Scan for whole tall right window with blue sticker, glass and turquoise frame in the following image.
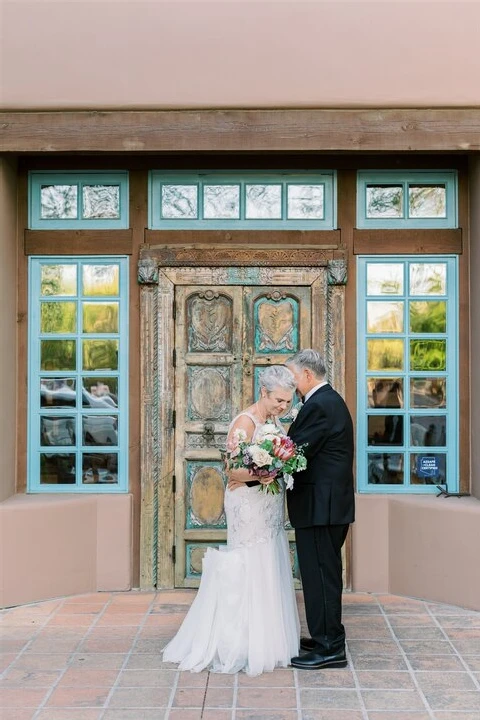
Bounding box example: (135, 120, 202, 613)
(357, 256, 458, 493)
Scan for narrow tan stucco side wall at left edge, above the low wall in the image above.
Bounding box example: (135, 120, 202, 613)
(0, 157, 17, 502)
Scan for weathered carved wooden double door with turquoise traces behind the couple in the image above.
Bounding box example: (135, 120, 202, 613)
(174, 285, 312, 587)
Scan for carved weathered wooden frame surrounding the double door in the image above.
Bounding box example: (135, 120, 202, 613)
(138, 246, 347, 589)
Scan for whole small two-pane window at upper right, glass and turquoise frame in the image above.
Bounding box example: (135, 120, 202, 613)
(357, 171, 458, 228)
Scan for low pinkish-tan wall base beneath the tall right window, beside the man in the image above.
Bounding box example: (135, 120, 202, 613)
(352, 495, 480, 610)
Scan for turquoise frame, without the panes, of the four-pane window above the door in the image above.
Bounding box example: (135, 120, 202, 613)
(148, 170, 337, 230)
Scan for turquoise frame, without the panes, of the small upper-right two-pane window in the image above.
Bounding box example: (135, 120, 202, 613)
(357, 170, 458, 229)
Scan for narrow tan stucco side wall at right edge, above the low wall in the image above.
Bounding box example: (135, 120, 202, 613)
(470, 156, 480, 500)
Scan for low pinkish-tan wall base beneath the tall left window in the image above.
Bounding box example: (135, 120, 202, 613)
(0, 495, 132, 607)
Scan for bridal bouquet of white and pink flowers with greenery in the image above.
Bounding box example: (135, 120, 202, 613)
(227, 423, 307, 494)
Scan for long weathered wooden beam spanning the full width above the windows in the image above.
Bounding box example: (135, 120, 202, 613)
(0, 108, 480, 154)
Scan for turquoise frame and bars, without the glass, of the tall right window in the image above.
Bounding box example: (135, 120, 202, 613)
(356, 255, 459, 494)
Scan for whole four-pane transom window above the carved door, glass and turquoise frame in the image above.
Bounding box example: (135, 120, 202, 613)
(149, 171, 336, 229)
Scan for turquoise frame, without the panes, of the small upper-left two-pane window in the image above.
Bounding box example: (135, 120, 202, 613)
(28, 170, 129, 230)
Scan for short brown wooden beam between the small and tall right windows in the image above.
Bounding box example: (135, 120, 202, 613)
(353, 229, 463, 255)
